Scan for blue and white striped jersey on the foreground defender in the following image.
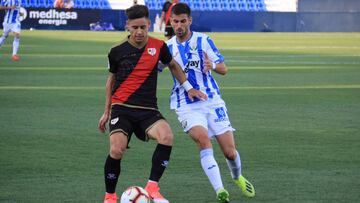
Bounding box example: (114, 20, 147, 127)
(166, 32, 224, 109)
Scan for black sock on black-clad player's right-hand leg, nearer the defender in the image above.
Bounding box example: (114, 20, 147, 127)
(149, 144, 172, 182)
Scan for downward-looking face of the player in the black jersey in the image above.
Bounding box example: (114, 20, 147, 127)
(126, 18, 150, 44)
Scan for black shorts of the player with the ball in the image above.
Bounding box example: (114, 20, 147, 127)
(109, 105, 165, 141)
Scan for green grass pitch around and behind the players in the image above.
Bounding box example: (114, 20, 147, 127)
(0, 30, 360, 203)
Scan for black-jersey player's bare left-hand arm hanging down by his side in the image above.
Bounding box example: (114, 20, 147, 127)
(98, 73, 115, 133)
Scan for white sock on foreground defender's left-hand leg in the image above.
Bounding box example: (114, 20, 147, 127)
(200, 148, 224, 192)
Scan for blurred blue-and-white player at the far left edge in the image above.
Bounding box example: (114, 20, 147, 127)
(0, 0, 21, 61)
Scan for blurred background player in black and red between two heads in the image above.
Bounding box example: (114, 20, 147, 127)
(160, 0, 179, 39)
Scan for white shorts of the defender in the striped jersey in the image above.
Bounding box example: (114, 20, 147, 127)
(175, 99, 235, 138)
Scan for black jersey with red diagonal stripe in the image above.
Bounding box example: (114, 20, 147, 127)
(108, 37, 172, 109)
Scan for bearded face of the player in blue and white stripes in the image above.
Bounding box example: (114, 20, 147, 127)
(171, 14, 192, 40)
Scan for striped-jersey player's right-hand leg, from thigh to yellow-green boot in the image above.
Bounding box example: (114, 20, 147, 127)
(216, 130, 255, 197)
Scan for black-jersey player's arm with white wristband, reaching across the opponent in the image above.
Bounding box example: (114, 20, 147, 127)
(168, 59, 207, 101)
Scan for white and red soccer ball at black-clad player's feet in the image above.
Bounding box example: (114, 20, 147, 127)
(120, 186, 150, 203)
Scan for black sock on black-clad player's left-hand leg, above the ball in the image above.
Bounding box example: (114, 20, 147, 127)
(104, 155, 121, 193)
